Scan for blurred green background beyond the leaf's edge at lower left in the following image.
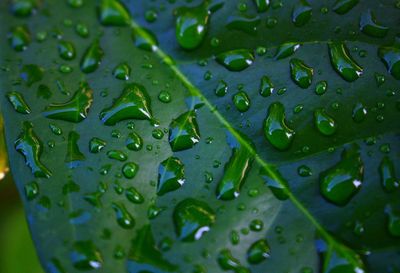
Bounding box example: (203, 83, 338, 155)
(0, 117, 44, 273)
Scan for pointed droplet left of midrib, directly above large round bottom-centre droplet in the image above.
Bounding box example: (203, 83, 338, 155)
(157, 157, 185, 196)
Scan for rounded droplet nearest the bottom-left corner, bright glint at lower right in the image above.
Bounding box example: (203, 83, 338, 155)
(71, 241, 103, 271)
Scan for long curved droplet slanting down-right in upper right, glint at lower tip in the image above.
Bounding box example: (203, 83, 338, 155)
(329, 42, 363, 82)
